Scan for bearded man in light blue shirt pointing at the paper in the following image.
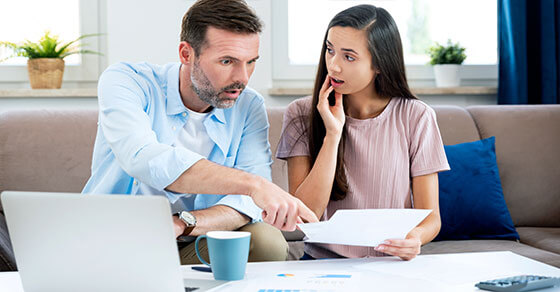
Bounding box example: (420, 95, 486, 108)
(83, 0, 317, 264)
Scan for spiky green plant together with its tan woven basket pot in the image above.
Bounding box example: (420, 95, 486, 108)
(0, 31, 101, 89)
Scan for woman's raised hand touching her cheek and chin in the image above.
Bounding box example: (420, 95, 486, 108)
(317, 76, 346, 138)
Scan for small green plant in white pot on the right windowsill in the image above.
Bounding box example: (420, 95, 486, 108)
(428, 40, 467, 87)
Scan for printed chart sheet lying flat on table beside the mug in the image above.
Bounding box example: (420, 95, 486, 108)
(249, 271, 359, 292)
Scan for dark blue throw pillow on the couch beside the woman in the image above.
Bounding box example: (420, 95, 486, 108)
(434, 137, 519, 240)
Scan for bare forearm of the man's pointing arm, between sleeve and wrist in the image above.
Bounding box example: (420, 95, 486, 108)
(166, 159, 263, 195)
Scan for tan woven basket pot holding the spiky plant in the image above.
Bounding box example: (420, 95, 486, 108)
(27, 58, 64, 89)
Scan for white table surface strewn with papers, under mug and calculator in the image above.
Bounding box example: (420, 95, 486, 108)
(0, 251, 560, 292)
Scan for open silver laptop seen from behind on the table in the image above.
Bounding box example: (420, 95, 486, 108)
(1, 191, 225, 292)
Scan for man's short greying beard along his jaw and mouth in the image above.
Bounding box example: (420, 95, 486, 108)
(191, 60, 245, 108)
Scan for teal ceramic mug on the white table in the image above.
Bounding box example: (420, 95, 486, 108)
(194, 231, 251, 281)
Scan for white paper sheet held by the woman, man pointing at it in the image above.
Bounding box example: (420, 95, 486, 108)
(298, 209, 432, 246)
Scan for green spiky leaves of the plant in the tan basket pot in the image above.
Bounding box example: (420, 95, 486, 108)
(0, 31, 102, 62)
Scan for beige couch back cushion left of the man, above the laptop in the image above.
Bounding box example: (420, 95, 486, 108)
(0, 110, 97, 202)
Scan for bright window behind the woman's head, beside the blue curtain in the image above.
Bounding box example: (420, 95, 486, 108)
(272, 0, 497, 85)
